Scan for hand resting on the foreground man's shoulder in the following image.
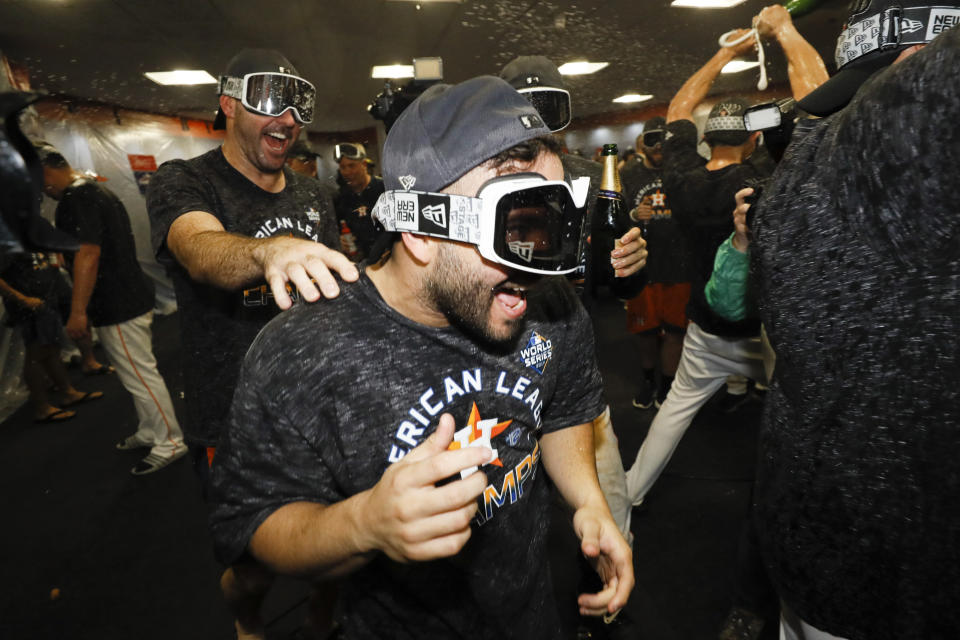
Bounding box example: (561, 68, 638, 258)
(254, 236, 360, 309)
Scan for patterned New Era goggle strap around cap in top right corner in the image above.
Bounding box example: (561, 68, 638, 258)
(834, 5, 960, 69)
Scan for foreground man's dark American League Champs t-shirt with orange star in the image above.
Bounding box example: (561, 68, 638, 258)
(211, 275, 605, 640)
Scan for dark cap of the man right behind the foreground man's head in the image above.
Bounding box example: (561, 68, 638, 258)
(500, 56, 571, 131)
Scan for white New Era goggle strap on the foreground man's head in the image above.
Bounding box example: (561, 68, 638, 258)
(373, 191, 483, 244)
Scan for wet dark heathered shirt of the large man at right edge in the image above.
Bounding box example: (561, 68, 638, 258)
(751, 28, 960, 640)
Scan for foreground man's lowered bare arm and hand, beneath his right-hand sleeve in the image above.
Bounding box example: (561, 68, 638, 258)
(540, 423, 634, 616)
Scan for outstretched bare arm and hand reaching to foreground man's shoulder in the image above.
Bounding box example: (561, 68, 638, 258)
(166, 211, 359, 309)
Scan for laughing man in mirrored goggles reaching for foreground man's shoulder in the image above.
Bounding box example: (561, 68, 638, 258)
(147, 49, 358, 638)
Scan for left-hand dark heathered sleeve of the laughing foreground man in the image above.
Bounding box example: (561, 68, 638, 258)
(210, 318, 342, 564)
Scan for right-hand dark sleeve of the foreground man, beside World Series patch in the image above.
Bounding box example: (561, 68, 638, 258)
(543, 300, 606, 433)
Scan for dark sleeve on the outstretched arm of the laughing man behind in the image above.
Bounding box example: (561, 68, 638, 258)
(147, 160, 216, 264)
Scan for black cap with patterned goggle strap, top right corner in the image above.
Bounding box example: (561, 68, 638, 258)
(797, 0, 960, 116)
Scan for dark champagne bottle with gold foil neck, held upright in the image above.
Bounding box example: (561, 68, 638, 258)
(591, 144, 643, 299)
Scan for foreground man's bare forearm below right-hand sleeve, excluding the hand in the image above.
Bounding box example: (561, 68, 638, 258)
(540, 423, 612, 518)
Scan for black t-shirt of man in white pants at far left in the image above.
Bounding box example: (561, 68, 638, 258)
(56, 178, 154, 327)
